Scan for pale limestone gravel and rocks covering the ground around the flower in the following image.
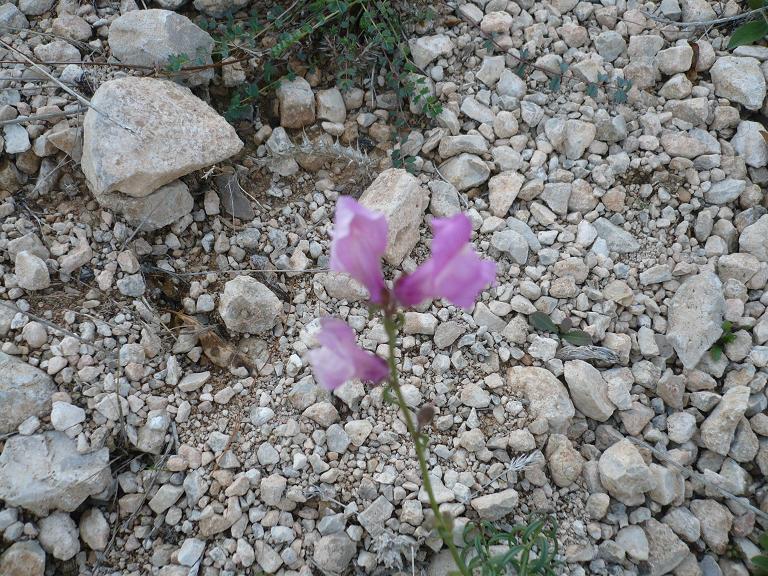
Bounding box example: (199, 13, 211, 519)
(0, 0, 768, 576)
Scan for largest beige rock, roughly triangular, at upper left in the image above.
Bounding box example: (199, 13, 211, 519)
(82, 76, 243, 198)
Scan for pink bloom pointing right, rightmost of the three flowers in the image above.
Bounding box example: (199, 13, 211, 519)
(395, 214, 496, 308)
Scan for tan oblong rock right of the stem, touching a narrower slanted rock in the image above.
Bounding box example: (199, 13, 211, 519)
(507, 366, 576, 432)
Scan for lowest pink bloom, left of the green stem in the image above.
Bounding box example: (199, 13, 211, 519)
(309, 316, 389, 390)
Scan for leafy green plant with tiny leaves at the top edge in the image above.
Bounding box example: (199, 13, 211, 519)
(200, 0, 442, 130)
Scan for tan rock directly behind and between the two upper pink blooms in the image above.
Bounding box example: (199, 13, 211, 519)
(360, 168, 429, 266)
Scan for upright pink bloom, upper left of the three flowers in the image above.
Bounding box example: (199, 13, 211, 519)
(331, 196, 387, 303)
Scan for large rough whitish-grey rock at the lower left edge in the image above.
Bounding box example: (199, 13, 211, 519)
(0, 432, 112, 516)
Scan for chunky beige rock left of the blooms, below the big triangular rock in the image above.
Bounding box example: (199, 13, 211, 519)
(219, 276, 283, 334)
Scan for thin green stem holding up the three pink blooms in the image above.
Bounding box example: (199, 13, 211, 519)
(384, 313, 472, 576)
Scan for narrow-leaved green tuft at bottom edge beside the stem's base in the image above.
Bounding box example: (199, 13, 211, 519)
(462, 516, 557, 576)
